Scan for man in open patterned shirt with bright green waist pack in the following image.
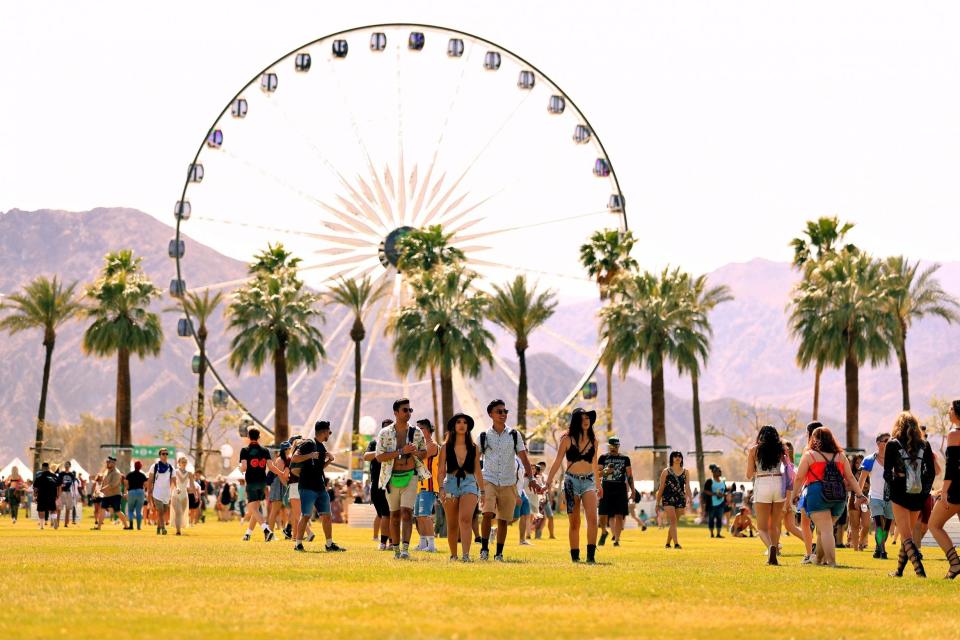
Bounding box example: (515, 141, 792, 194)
(376, 398, 430, 560)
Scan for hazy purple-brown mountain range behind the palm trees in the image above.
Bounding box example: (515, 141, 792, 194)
(0, 208, 960, 468)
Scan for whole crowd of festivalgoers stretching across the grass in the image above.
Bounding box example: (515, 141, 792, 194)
(2, 398, 960, 578)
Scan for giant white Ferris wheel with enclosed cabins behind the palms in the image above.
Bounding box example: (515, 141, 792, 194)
(168, 24, 627, 442)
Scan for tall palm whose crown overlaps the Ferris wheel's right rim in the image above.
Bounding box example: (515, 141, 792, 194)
(580, 229, 639, 431)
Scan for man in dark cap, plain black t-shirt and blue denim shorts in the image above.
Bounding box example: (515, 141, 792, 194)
(290, 420, 346, 551)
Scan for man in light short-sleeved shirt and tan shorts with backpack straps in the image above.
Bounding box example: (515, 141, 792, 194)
(480, 400, 533, 562)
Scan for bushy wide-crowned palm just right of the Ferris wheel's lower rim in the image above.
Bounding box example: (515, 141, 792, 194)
(600, 269, 708, 466)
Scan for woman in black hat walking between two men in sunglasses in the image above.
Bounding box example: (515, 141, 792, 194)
(437, 413, 483, 562)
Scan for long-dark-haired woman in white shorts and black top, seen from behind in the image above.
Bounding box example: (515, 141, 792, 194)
(747, 425, 786, 565)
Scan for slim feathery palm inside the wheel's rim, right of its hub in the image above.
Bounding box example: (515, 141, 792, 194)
(490, 275, 557, 434)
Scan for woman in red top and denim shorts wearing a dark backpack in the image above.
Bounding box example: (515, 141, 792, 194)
(793, 427, 864, 567)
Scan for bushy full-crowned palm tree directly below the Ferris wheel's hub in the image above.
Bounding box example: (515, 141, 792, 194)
(387, 265, 494, 424)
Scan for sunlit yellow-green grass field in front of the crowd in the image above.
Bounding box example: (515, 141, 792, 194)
(0, 518, 960, 640)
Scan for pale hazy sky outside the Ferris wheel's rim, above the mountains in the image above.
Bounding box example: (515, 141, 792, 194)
(0, 0, 960, 271)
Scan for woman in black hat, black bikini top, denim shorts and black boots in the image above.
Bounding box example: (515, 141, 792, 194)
(547, 407, 603, 564)
